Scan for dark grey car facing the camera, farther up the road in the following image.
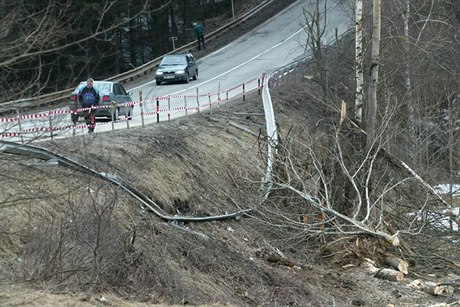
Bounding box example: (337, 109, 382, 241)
(155, 53, 198, 85)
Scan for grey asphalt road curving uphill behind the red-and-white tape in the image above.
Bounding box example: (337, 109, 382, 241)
(1, 0, 351, 142)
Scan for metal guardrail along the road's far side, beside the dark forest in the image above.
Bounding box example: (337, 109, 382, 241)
(0, 0, 274, 113)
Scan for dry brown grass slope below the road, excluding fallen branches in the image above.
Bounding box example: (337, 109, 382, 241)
(0, 0, 460, 306)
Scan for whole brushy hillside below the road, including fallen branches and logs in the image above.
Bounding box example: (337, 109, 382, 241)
(0, 1, 460, 306)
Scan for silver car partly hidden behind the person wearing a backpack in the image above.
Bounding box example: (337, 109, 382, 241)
(69, 81, 134, 124)
